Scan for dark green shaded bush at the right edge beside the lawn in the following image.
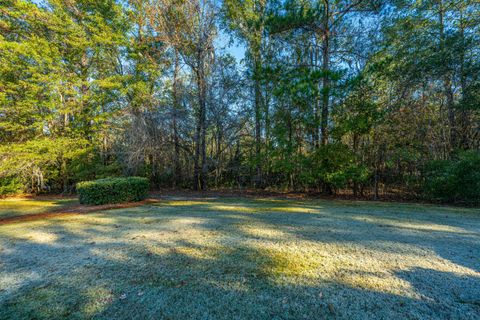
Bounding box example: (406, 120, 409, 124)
(425, 151, 480, 204)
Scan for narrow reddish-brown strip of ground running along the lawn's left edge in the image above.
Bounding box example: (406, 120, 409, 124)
(0, 199, 160, 225)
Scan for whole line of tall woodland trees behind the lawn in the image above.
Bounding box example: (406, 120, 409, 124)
(0, 0, 480, 203)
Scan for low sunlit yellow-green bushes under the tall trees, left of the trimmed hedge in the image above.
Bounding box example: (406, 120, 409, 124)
(0, 138, 123, 196)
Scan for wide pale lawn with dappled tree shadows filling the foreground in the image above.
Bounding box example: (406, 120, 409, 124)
(0, 198, 480, 319)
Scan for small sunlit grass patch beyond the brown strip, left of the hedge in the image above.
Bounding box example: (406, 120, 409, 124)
(0, 197, 78, 219)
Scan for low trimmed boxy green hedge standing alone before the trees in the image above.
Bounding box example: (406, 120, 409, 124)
(77, 177, 150, 205)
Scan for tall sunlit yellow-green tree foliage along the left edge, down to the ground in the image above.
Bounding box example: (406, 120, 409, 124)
(0, 0, 128, 193)
